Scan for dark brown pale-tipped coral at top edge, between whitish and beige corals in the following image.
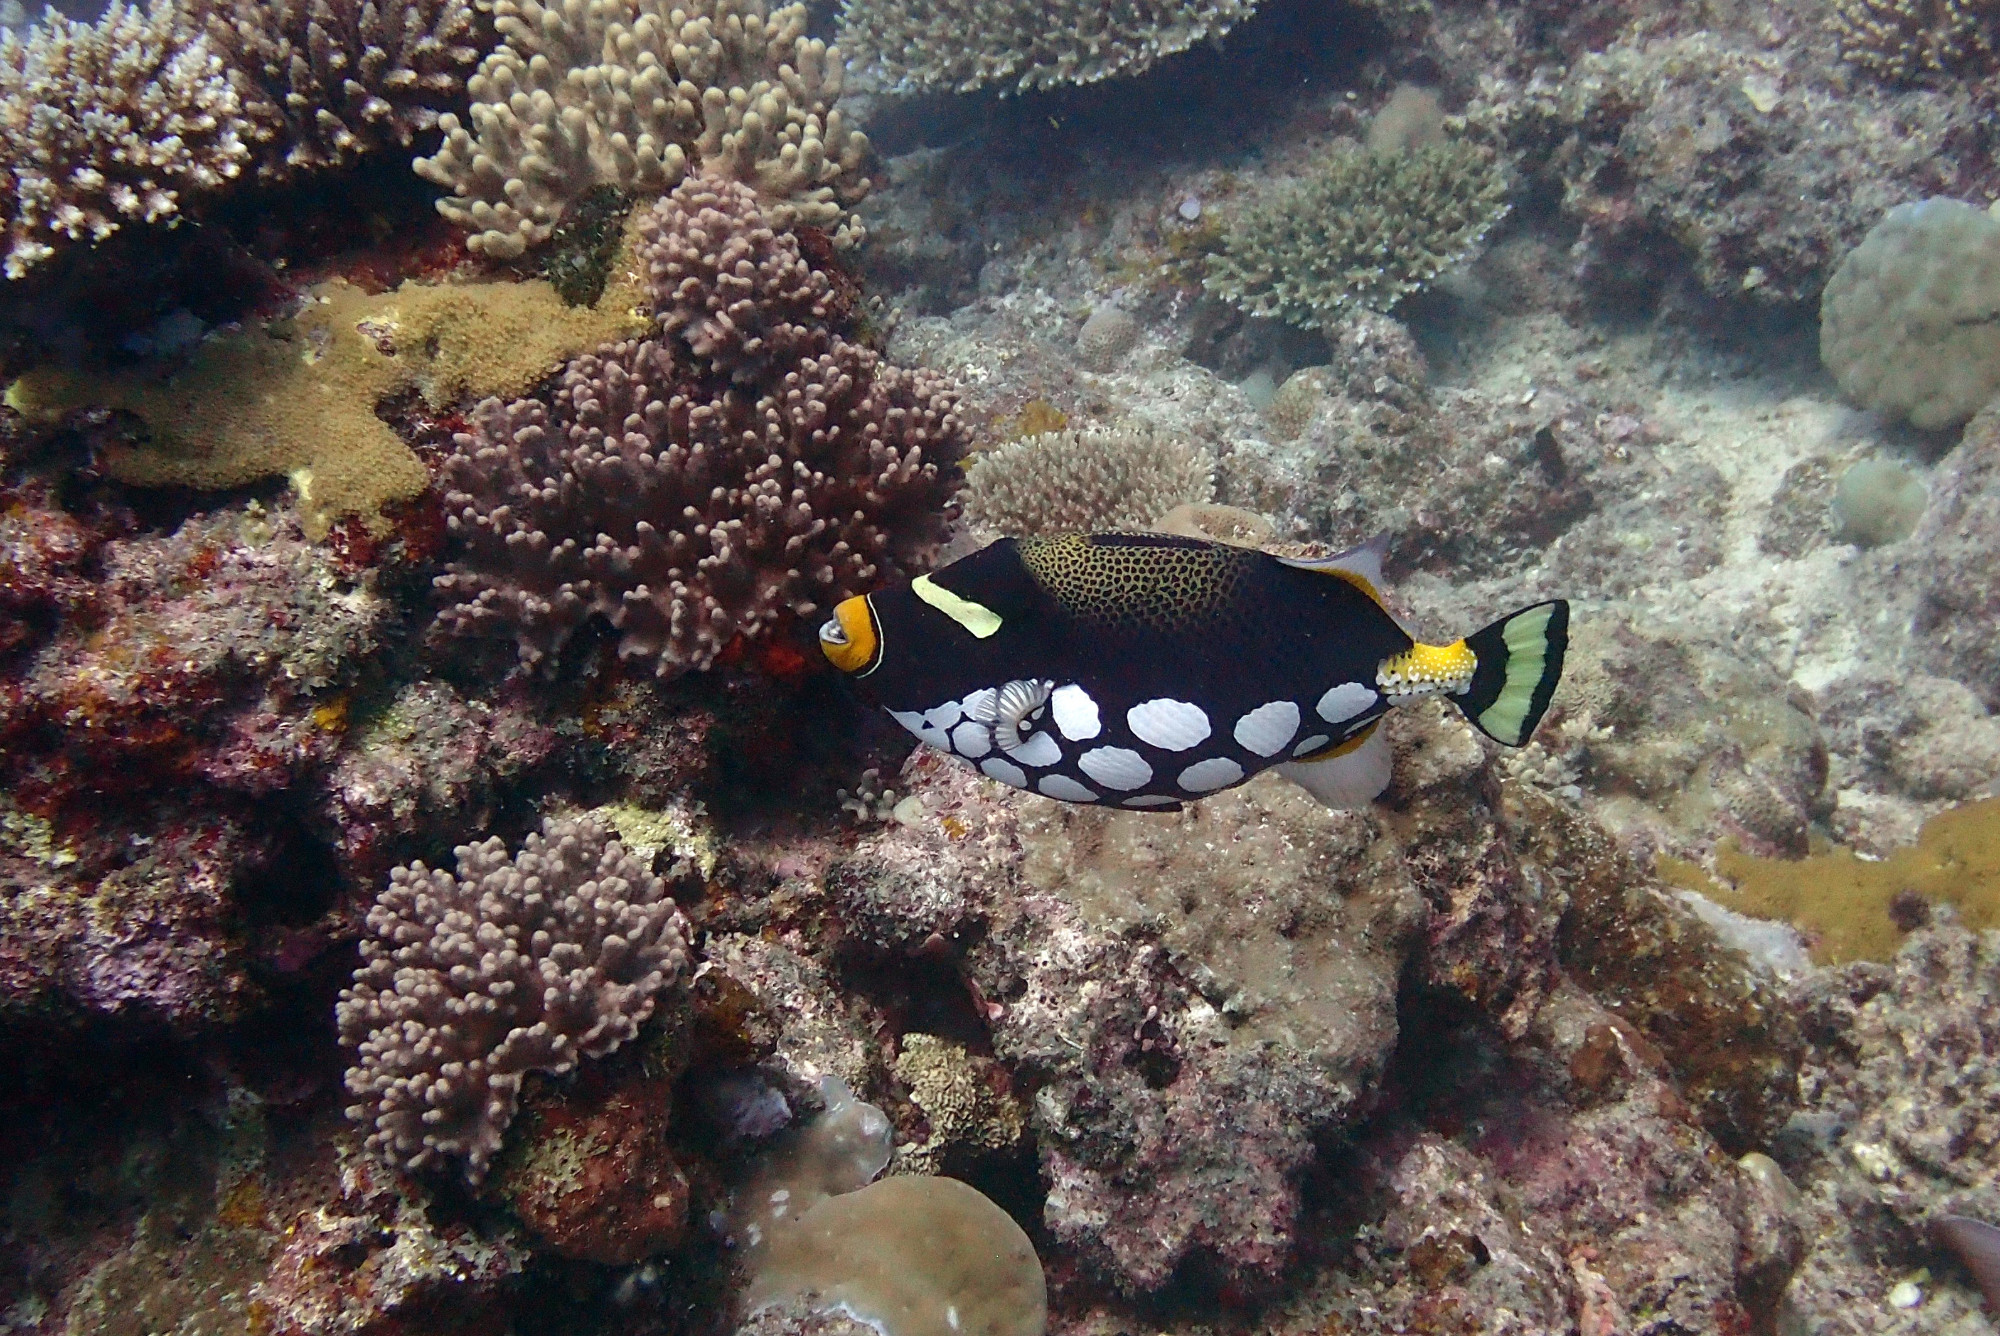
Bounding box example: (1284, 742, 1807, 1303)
(188, 0, 490, 176)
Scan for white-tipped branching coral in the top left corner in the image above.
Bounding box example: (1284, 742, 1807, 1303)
(0, 0, 254, 278)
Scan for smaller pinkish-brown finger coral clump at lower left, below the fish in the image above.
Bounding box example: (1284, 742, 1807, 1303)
(336, 818, 688, 1184)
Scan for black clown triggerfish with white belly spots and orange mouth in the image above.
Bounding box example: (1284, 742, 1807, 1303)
(820, 534, 1570, 810)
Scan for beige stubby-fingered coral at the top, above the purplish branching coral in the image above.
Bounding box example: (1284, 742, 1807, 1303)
(414, 0, 868, 260)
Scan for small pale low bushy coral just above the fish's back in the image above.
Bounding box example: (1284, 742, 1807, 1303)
(966, 426, 1216, 536)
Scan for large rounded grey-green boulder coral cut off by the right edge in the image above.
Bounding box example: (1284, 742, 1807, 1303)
(1820, 200, 2000, 430)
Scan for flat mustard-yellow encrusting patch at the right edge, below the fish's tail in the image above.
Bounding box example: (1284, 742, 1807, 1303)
(1660, 798, 2000, 964)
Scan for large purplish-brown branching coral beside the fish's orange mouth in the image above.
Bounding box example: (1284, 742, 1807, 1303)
(438, 180, 966, 676)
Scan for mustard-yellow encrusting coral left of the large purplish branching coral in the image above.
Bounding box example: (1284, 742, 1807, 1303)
(10, 235, 644, 538)
